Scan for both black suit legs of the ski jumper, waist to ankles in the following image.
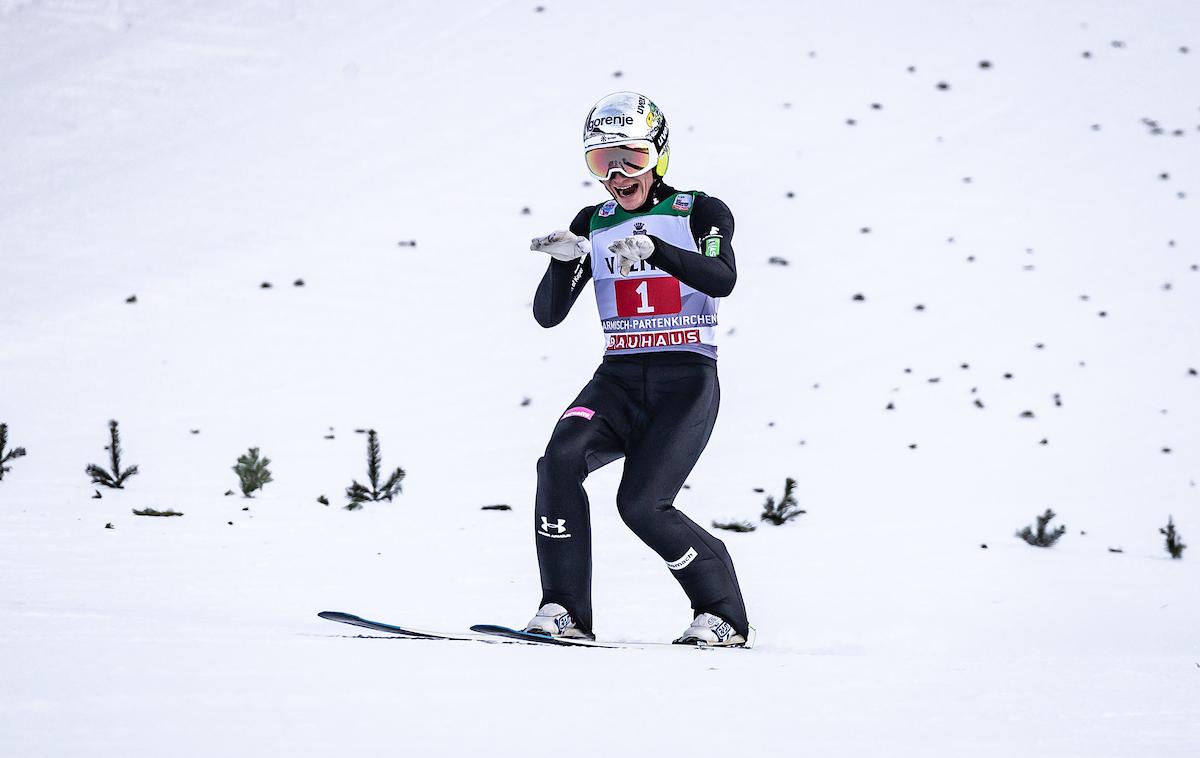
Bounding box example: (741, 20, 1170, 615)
(534, 362, 749, 636)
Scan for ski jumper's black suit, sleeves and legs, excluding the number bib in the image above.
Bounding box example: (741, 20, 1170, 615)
(533, 184, 749, 637)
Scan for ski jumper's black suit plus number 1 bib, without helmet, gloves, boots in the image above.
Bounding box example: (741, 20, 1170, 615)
(534, 184, 749, 636)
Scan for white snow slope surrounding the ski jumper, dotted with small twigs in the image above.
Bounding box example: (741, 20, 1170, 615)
(0, 0, 1200, 757)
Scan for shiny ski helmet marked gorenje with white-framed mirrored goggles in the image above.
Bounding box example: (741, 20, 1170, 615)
(583, 92, 671, 179)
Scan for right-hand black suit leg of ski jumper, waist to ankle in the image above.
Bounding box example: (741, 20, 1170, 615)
(617, 366, 749, 636)
